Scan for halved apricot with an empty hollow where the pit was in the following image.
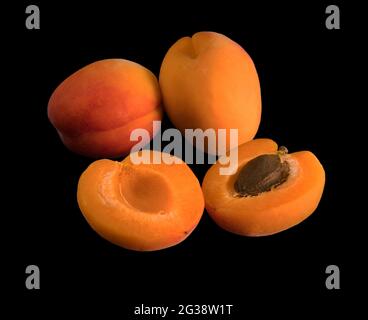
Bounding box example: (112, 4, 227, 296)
(77, 150, 204, 251)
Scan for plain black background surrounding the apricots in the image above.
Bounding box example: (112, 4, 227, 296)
(3, 1, 359, 319)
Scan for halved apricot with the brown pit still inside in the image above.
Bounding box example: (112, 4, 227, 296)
(202, 139, 325, 236)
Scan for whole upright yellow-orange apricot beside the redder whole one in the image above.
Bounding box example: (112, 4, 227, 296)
(159, 32, 261, 154)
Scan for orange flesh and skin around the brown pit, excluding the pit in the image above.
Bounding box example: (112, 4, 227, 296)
(202, 139, 325, 236)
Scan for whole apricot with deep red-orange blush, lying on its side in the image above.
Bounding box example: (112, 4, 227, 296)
(48, 59, 162, 158)
